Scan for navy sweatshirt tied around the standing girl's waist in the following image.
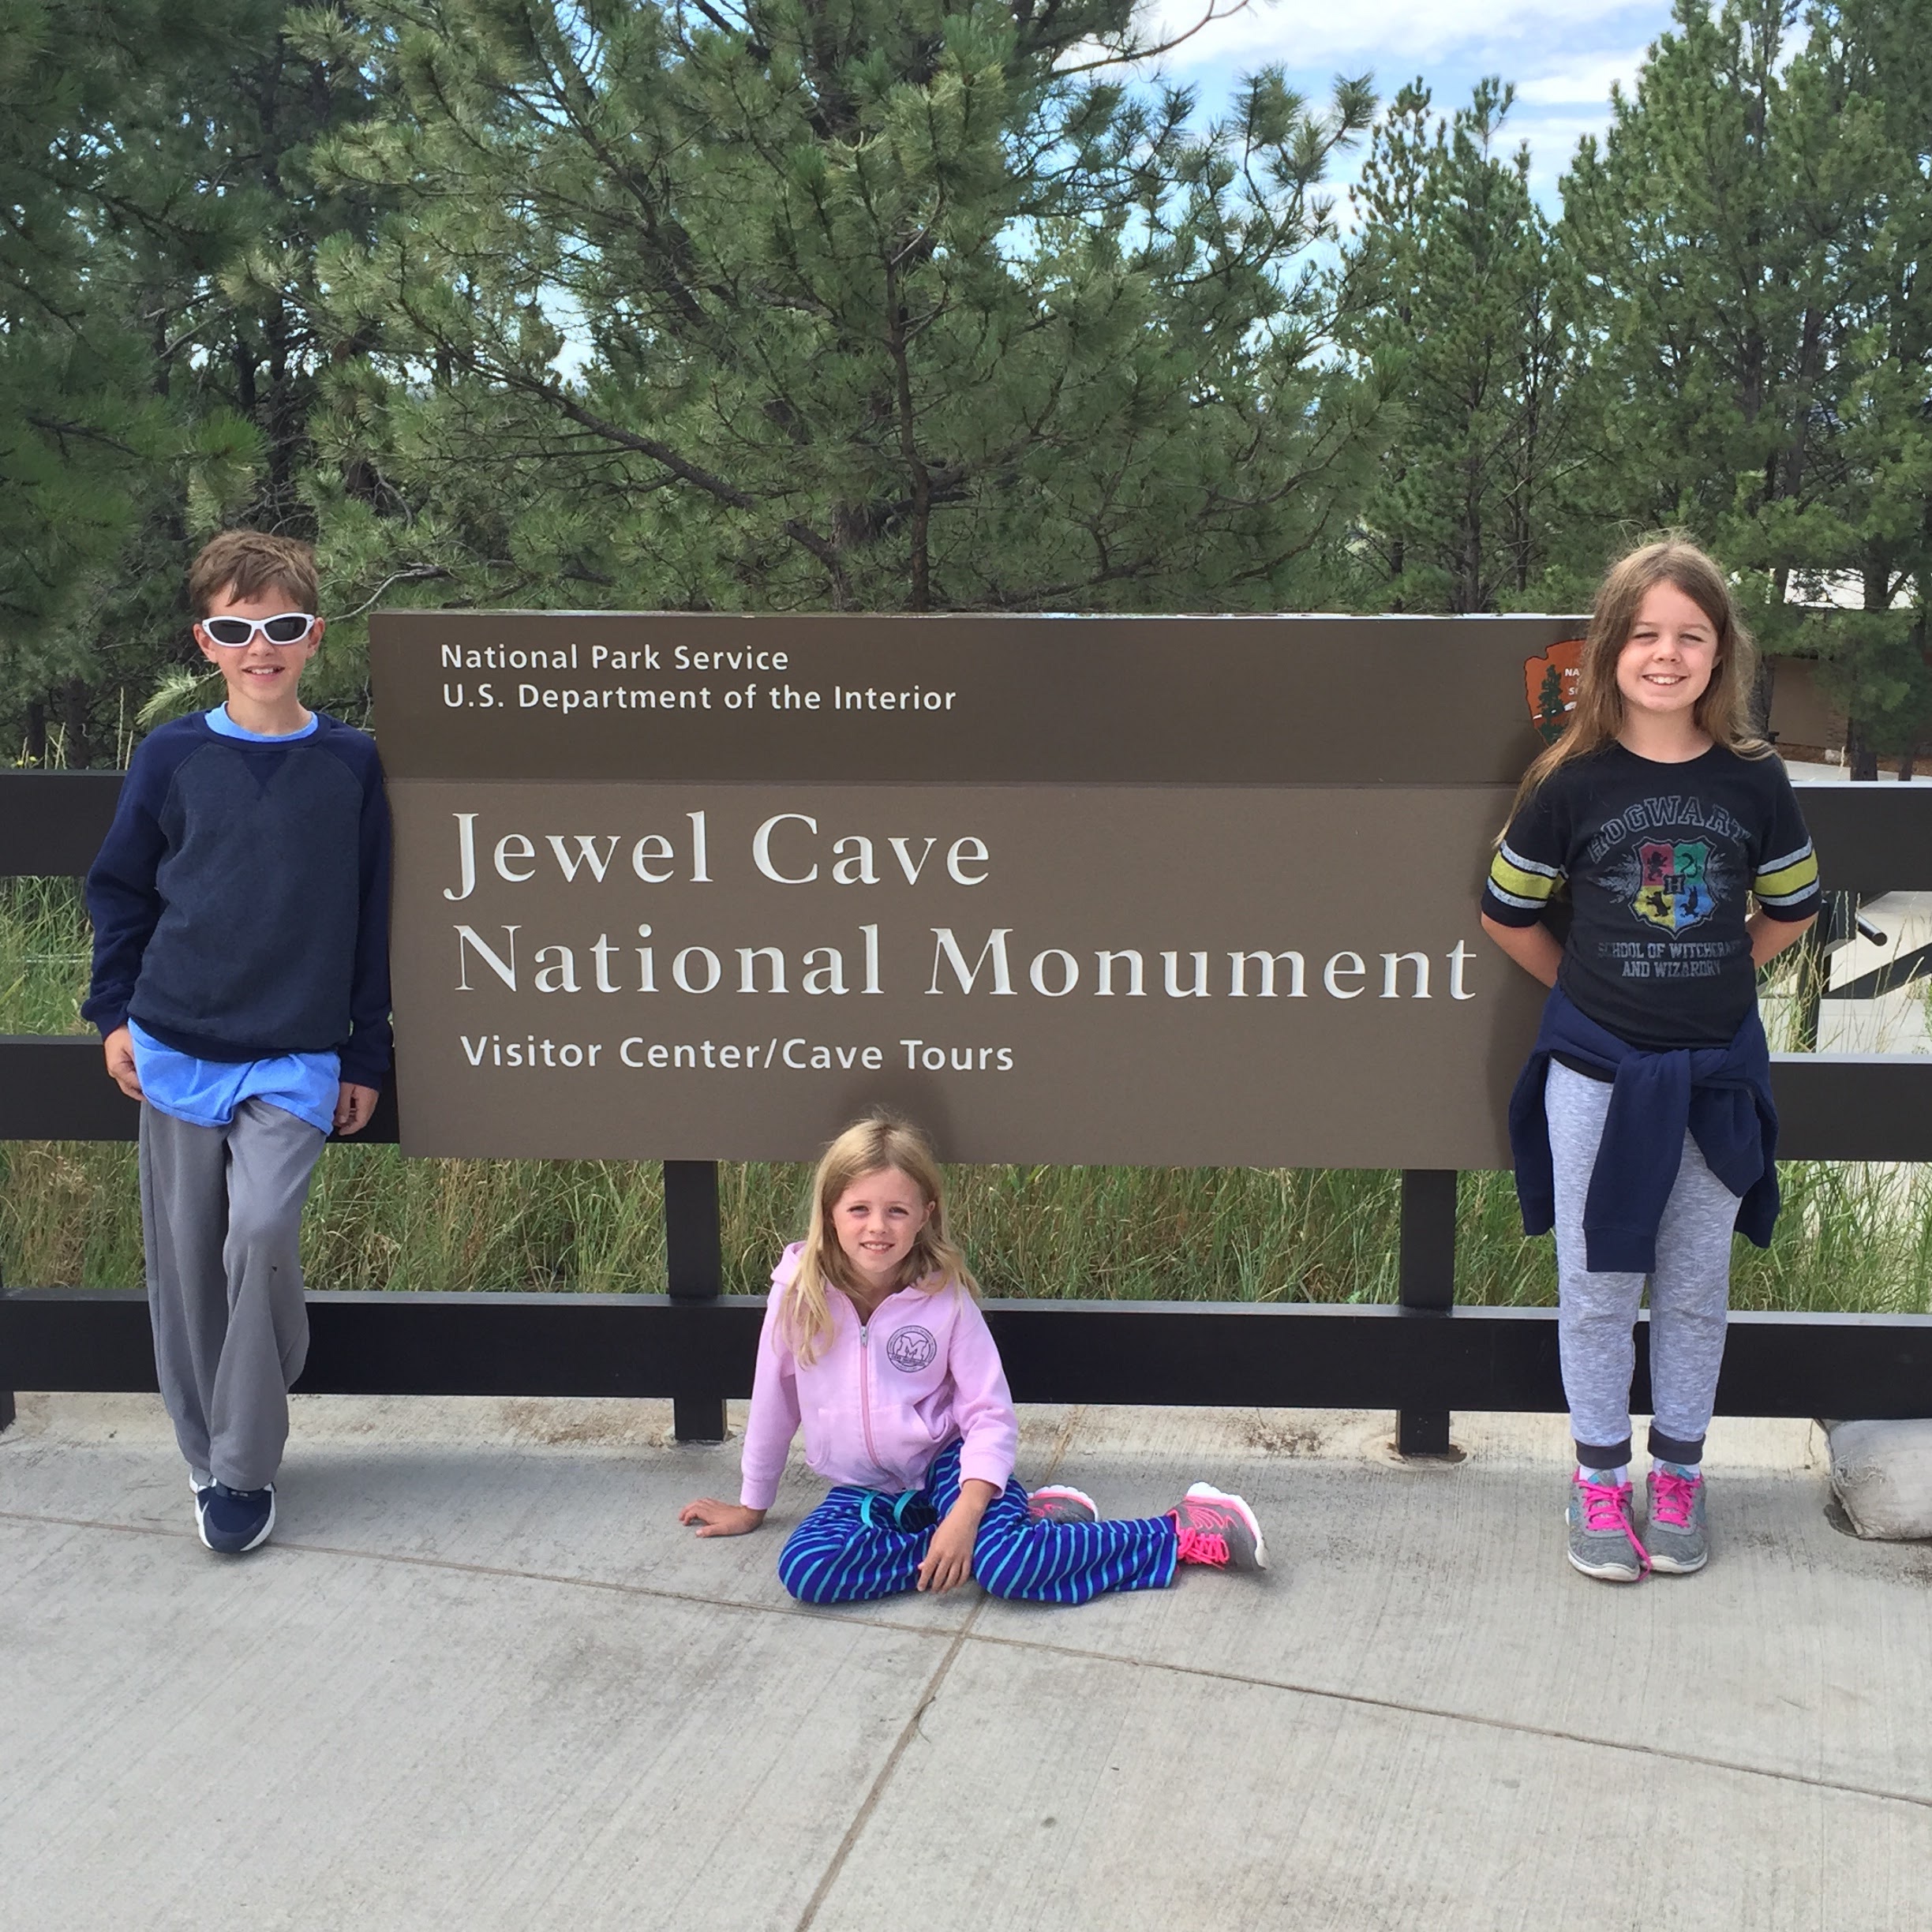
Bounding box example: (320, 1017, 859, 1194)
(1509, 987, 1777, 1275)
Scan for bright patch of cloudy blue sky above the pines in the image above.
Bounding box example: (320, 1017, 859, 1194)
(1146, 0, 1672, 212)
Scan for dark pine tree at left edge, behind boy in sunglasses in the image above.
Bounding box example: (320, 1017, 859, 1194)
(0, 0, 391, 763)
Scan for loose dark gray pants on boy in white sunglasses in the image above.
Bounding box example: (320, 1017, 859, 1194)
(141, 1099, 323, 1489)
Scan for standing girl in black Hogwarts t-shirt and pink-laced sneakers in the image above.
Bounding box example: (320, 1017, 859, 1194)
(1482, 541, 1818, 1582)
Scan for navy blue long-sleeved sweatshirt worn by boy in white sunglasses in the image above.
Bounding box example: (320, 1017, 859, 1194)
(81, 713, 390, 1086)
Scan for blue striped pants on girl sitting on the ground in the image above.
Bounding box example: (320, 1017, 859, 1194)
(779, 1443, 1174, 1604)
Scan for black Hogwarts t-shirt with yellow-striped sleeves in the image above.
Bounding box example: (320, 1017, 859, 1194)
(1482, 743, 1818, 1053)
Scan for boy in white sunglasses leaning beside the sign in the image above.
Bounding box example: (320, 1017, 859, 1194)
(81, 530, 390, 1556)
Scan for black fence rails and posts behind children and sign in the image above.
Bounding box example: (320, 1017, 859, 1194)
(0, 773, 1932, 1455)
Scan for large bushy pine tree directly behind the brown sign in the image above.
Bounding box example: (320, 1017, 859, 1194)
(297, 0, 1385, 649)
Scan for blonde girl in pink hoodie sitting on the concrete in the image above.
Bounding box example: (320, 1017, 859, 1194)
(678, 1114, 1267, 1604)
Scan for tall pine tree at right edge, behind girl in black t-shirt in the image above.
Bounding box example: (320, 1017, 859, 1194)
(1563, 0, 1932, 777)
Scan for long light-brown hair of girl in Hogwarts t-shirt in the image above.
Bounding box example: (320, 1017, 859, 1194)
(1509, 535, 1772, 818)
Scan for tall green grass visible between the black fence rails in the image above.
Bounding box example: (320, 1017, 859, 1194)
(0, 879, 1932, 1312)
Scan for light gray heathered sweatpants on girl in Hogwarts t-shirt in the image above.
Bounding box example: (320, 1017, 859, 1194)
(1544, 1061, 1737, 1468)
